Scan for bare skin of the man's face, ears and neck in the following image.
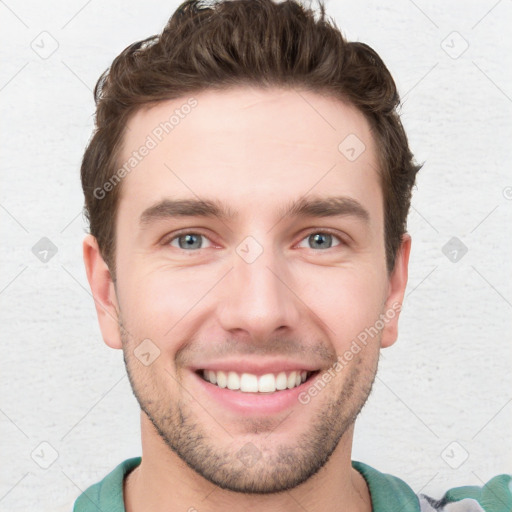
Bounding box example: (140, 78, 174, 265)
(83, 87, 410, 512)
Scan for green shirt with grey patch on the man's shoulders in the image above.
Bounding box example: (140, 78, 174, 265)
(73, 457, 512, 512)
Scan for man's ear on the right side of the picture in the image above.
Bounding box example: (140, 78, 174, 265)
(380, 233, 411, 348)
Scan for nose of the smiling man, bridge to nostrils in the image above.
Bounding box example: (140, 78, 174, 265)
(218, 240, 304, 343)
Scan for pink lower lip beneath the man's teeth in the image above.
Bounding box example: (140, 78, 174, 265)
(192, 372, 320, 416)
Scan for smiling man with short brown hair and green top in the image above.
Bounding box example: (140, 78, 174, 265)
(74, 0, 512, 512)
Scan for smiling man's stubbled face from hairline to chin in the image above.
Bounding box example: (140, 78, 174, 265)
(86, 88, 408, 493)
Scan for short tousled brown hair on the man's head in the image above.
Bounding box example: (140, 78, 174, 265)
(81, 0, 421, 281)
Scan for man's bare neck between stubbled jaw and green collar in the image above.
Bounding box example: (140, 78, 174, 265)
(123, 414, 372, 512)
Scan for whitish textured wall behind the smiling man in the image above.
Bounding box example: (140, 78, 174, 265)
(0, 0, 512, 511)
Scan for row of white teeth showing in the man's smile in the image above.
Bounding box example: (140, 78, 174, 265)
(203, 370, 310, 393)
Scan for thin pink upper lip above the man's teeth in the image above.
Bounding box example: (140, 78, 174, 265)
(192, 358, 320, 376)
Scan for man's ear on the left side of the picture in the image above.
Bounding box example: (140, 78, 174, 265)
(83, 235, 122, 349)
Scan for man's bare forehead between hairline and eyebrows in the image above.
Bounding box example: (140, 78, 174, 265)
(118, 87, 382, 227)
